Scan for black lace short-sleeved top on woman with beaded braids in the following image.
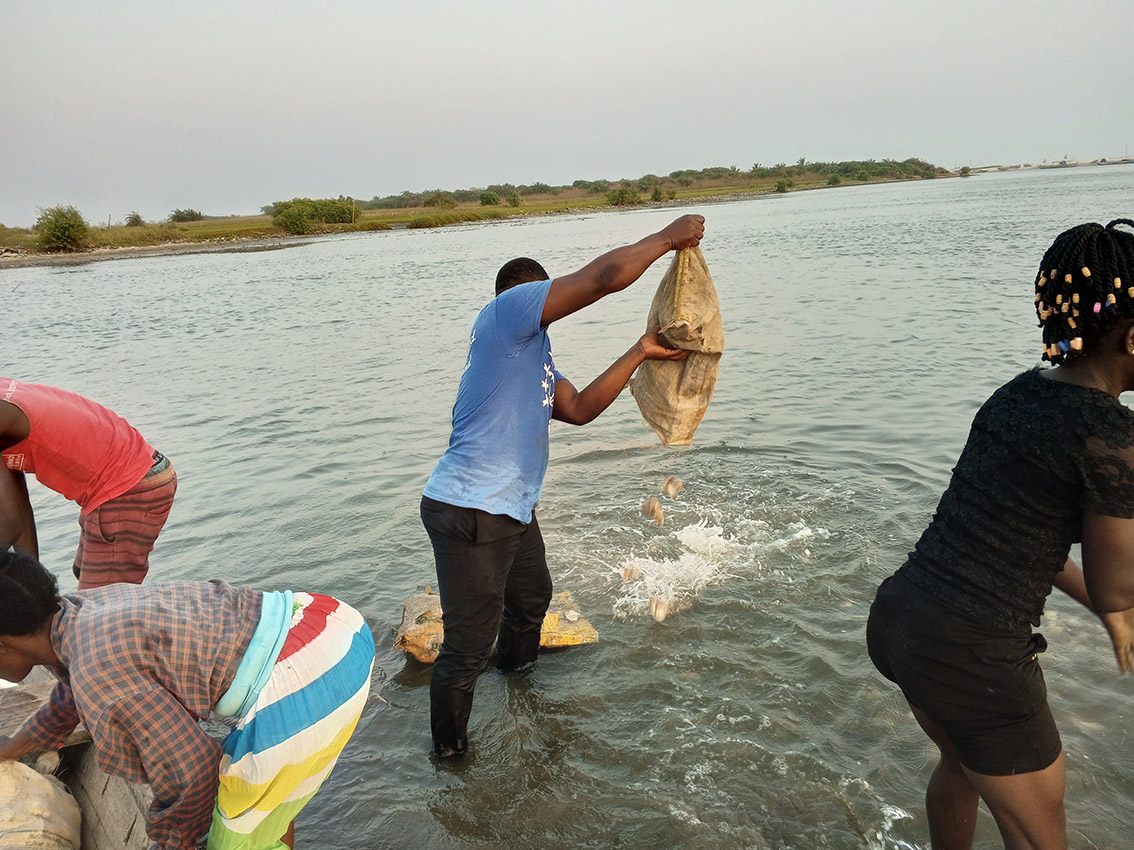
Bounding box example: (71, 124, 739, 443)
(899, 369, 1134, 634)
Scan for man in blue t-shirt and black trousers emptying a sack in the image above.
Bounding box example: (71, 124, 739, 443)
(421, 215, 704, 758)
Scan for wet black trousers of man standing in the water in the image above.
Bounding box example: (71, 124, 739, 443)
(421, 496, 551, 753)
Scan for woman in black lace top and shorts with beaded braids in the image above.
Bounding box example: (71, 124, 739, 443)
(866, 219, 1134, 850)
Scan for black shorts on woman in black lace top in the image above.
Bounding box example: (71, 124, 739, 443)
(866, 575, 1063, 776)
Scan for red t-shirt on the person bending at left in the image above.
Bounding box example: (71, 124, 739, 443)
(0, 377, 153, 513)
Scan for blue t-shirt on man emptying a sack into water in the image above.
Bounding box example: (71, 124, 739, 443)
(425, 280, 562, 522)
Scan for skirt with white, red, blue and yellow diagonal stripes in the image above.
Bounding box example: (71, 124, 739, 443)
(209, 593, 374, 850)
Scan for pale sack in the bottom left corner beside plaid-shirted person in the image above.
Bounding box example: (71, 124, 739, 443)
(0, 762, 82, 850)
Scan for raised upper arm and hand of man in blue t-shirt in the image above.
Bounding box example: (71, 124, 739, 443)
(540, 215, 705, 328)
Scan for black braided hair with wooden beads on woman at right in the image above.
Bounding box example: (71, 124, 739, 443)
(1035, 219, 1134, 364)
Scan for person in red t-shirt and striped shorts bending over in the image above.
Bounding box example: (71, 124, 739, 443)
(0, 377, 177, 589)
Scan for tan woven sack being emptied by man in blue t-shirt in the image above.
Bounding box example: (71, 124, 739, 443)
(631, 248, 725, 445)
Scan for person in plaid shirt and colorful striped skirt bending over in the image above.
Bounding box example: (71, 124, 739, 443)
(0, 552, 374, 850)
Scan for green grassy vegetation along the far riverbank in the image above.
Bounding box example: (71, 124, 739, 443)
(0, 159, 950, 253)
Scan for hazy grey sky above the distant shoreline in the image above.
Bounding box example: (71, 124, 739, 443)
(0, 0, 1134, 227)
